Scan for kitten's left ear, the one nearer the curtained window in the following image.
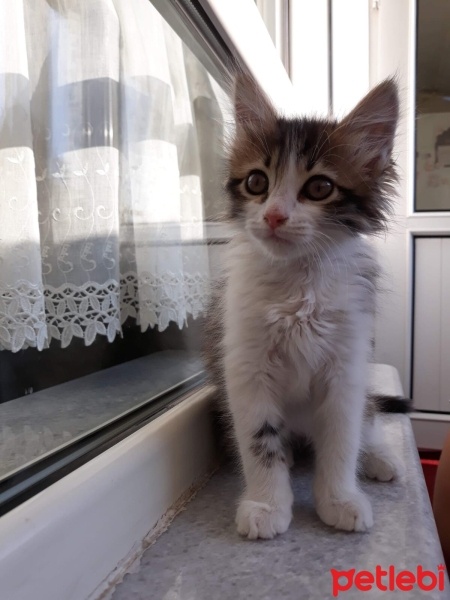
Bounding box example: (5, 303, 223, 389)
(233, 72, 277, 131)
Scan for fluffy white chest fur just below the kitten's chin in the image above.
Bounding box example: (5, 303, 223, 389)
(225, 234, 375, 380)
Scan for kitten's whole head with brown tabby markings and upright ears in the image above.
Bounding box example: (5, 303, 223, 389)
(227, 75, 398, 259)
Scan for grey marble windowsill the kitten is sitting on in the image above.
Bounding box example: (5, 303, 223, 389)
(111, 365, 450, 600)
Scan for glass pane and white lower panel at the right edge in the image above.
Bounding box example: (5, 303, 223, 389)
(411, 0, 450, 412)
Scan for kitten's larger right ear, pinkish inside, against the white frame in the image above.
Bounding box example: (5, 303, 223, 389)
(338, 79, 399, 173)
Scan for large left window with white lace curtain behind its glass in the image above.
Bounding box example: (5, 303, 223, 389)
(0, 0, 229, 510)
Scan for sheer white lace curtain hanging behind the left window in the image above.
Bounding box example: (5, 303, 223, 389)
(0, 0, 223, 352)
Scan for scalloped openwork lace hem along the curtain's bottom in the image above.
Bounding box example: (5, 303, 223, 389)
(0, 272, 209, 352)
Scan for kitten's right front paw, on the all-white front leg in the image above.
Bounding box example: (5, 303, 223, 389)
(316, 491, 373, 531)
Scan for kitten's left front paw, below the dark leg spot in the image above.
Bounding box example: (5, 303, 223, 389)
(236, 500, 292, 540)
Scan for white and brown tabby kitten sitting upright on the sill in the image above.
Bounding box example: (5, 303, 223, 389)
(207, 74, 408, 539)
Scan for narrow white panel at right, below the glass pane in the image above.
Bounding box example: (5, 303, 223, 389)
(413, 238, 442, 411)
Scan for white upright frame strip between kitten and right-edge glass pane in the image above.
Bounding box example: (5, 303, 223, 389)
(370, 0, 415, 394)
